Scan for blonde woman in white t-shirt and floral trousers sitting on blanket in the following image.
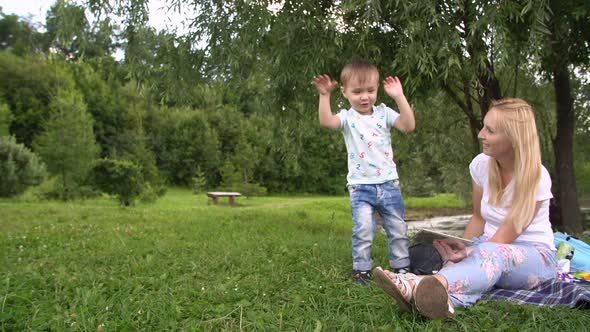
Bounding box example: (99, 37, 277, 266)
(373, 98, 557, 318)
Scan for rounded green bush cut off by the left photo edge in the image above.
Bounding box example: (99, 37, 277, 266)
(0, 136, 47, 197)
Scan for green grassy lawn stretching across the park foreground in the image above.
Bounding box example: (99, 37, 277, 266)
(0, 189, 590, 331)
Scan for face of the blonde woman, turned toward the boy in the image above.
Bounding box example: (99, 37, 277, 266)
(477, 108, 514, 159)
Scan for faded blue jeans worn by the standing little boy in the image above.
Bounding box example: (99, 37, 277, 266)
(348, 180, 410, 271)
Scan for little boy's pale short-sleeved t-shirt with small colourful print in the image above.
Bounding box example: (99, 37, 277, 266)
(336, 104, 399, 184)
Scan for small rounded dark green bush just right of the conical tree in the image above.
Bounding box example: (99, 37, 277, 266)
(90, 159, 144, 206)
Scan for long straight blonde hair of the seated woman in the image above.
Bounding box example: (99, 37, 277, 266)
(489, 98, 541, 234)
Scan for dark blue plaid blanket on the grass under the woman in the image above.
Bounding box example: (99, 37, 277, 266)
(483, 278, 590, 309)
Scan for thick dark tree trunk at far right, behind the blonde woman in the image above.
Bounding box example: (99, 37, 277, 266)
(551, 66, 583, 234)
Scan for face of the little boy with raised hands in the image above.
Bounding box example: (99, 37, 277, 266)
(341, 74, 379, 115)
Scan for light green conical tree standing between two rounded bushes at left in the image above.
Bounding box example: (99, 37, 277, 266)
(34, 90, 99, 199)
